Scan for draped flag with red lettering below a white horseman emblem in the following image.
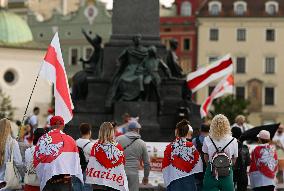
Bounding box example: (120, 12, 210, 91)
(86, 141, 128, 191)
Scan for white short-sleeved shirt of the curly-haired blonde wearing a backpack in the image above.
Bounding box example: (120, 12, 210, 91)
(202, 136, 238, 161)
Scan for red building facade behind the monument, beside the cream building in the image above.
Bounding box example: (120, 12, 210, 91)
(160, 0, 201, 73)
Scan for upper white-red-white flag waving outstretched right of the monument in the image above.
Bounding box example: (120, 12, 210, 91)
(186, 54, 233, 93)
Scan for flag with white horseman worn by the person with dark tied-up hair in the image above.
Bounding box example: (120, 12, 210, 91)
(162, 138, 203, 186)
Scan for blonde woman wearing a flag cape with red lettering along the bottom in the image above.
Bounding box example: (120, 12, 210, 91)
(86, 122, 128, 191)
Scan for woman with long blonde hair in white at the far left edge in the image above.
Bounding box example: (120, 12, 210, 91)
(0, 118, 23, 191)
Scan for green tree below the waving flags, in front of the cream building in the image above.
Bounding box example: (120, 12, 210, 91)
(210, 95, 249, 124)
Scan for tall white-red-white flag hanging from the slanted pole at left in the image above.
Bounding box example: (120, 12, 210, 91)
(40, 33, 73, 123)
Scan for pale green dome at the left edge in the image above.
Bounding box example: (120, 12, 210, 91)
(0, 8, 33, 45)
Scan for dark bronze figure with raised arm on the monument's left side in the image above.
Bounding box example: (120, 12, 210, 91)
(80, 29, 103, 76)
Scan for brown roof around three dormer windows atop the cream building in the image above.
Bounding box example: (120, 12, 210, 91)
(198, 0, 284, 18)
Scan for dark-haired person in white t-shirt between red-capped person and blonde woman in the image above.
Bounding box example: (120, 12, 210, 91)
(72, 123, 94, 191)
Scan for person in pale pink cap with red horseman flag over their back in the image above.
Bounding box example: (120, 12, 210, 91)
(249, 130, 278, 191)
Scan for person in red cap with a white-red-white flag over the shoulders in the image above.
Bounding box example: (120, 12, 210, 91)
(33, 116, 83, 191)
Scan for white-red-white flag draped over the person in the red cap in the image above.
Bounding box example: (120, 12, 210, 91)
(33, 129, 83, 190)
